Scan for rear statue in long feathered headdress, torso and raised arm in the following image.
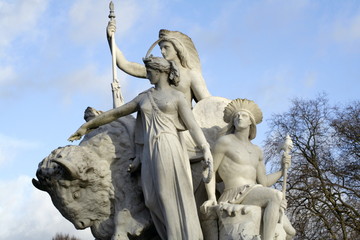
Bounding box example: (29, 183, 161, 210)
(107, 20, 211, 105)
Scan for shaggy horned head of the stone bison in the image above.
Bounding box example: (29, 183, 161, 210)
(33, 146, 114, 229)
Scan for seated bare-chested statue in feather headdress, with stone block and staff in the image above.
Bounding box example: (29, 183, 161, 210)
(201, 98, 295, 240)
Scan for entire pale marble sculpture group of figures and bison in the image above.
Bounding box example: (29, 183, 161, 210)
(33, 2, 295, 240)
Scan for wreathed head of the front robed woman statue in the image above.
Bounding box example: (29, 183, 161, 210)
(143, 56, 180, 86)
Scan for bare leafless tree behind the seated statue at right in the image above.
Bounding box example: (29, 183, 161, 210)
(264, 94, 360, 240)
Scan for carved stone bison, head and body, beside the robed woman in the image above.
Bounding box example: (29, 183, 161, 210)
(33, 116, 152, 240)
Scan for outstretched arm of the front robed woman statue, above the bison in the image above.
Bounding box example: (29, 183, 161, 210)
(68, 97, 138, 141)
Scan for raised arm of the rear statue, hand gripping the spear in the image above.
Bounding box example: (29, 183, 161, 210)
(106, 20, 146, 78)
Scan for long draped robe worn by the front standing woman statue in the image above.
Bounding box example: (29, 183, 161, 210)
(136, 89, 203, 240)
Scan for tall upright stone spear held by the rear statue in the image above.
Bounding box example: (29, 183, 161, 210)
(109, 1, 124, 108)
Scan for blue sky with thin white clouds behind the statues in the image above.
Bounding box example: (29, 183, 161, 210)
(0, 0, 360, 240)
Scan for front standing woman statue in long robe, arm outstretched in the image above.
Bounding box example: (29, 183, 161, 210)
(69, 57, 212, 240)
